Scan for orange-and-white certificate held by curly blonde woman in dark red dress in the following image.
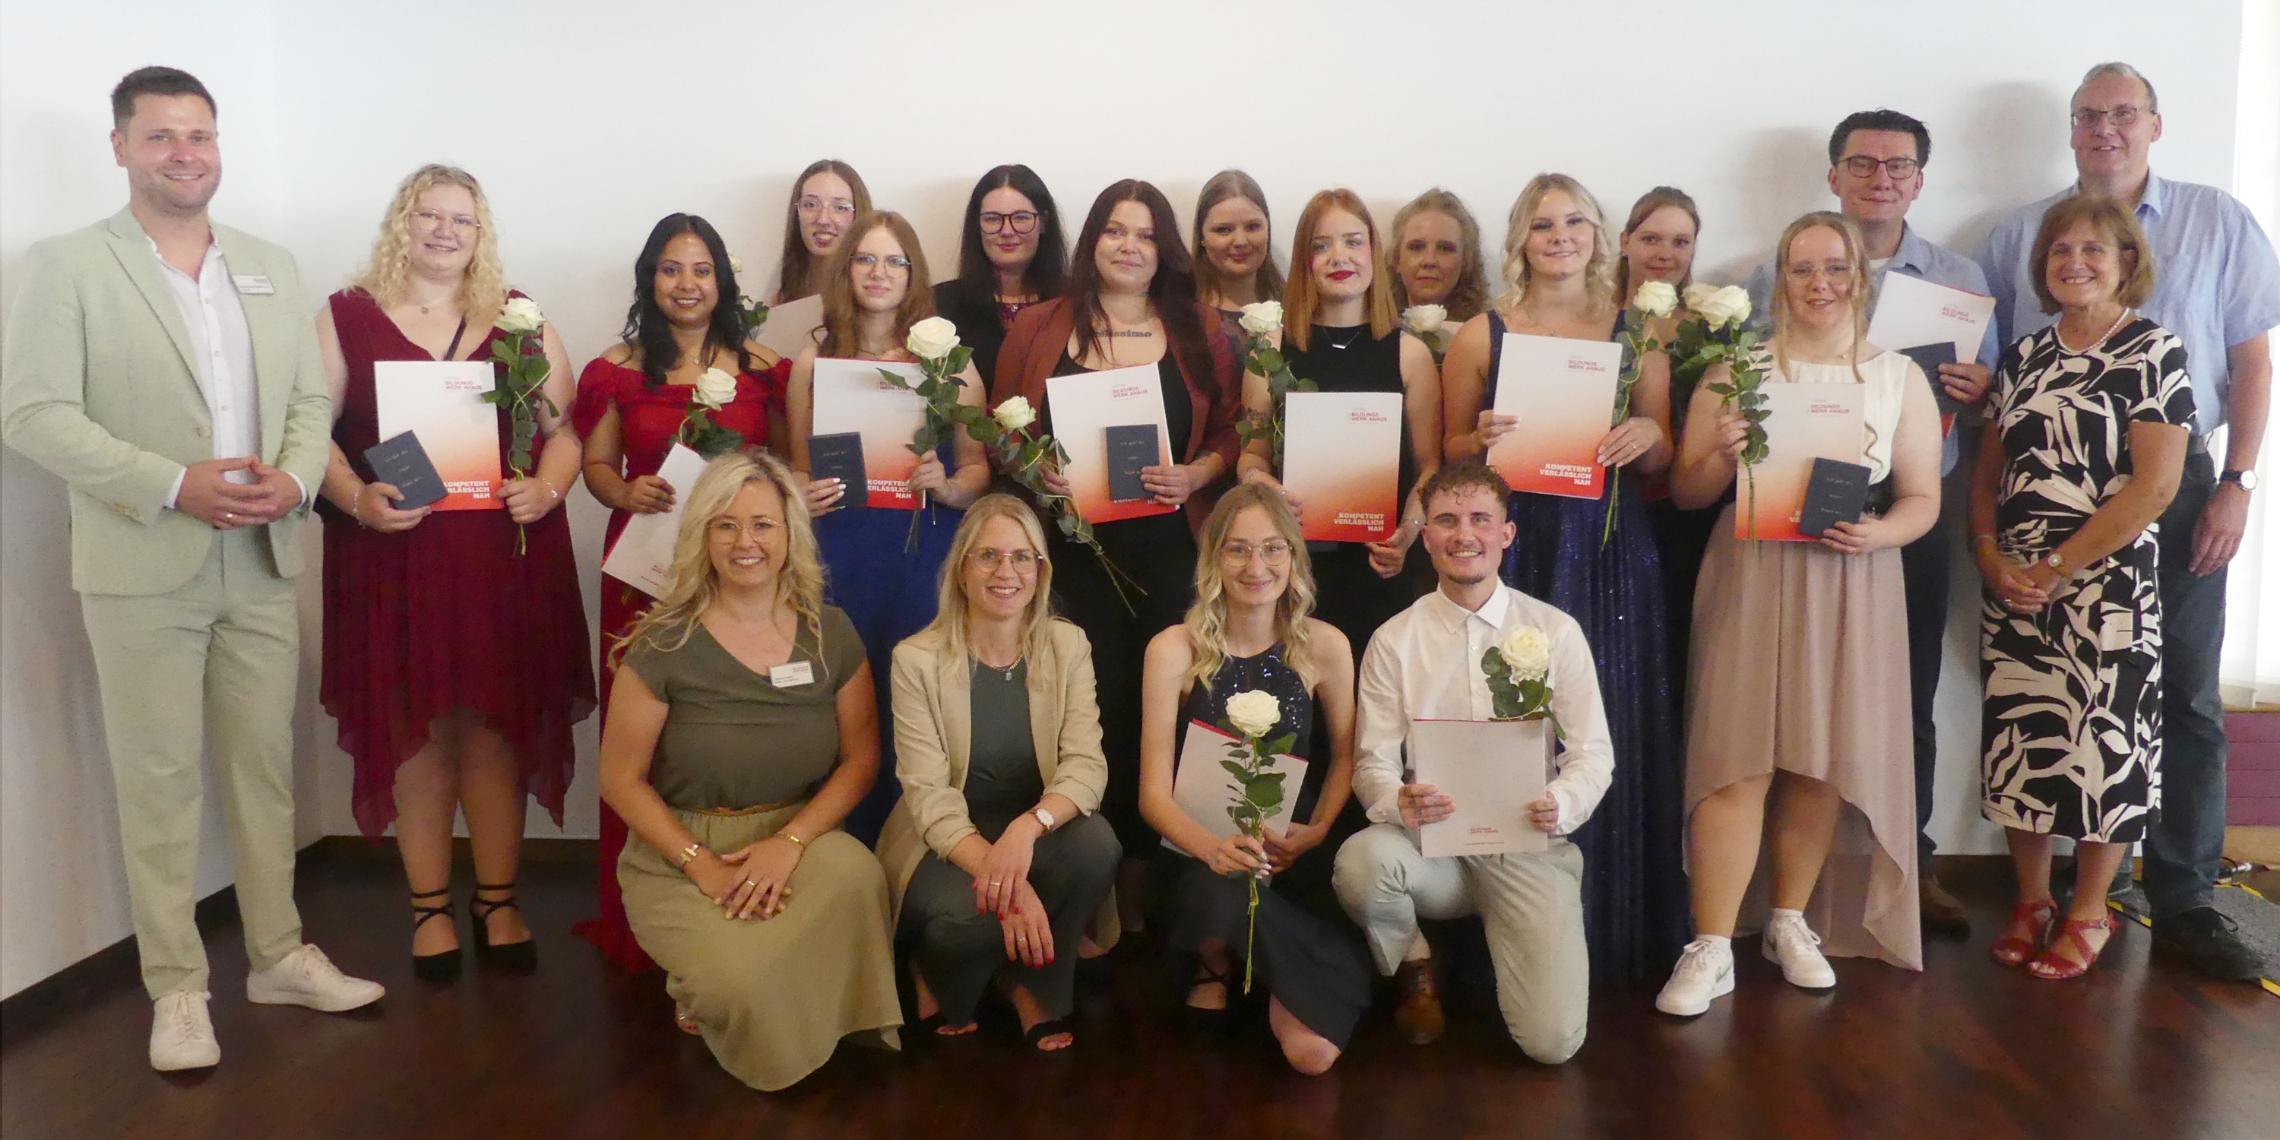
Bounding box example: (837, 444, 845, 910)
(372, 360, 506, 511)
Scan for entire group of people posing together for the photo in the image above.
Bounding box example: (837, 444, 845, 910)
(0, 64, 2280, 1090)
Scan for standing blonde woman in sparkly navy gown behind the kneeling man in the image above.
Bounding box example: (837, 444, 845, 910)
(1441, 173, 1687, 983)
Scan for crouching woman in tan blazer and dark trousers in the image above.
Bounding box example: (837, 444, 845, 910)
(878, 495, 1122, 1053)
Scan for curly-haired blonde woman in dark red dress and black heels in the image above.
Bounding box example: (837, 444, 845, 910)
(317, 166, 595, 978)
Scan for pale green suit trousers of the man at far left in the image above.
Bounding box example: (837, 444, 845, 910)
(80, 527, 301, 999)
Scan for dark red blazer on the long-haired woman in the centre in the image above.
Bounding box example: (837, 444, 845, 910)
(990, 296, 1243, 527)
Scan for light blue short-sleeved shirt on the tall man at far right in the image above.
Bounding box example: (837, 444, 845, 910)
(1979, 176, 2280, 435)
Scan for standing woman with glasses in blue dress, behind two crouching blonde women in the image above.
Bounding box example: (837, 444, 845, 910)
(784, 212, 990, 844)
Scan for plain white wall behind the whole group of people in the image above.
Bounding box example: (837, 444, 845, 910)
(0, 0, 2241, 992)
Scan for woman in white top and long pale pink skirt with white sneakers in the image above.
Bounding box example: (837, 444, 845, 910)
(1655, 212, 1940, 1017)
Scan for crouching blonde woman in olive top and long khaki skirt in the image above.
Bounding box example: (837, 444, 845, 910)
(602, 444, 903, 1092)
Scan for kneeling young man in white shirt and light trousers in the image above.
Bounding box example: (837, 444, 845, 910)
(1336, 463, 1614, 1065)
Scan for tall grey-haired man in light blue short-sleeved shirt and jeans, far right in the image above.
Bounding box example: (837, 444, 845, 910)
(1979, 64, 2280, 980)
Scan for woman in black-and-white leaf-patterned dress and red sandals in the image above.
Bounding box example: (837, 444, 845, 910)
(1972, 196, 2193, 978)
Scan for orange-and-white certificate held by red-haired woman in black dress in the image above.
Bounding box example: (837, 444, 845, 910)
(1284, 392, 1404, 543)
